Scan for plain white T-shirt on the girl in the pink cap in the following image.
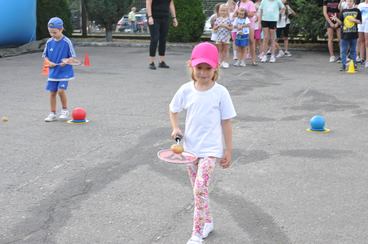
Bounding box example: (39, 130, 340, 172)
(170, 81, 236, 158)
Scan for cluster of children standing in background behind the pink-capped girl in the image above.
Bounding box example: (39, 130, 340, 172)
(210, 0, 296, 68)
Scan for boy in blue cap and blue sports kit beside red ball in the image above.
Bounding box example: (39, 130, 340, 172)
(42, 17, 76, 122)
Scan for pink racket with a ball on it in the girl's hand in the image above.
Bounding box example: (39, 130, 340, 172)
(157, 136, 198, 164)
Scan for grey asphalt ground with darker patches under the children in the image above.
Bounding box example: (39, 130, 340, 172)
(0, 45, 368, 244)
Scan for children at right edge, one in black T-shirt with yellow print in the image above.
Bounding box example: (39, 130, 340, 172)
(323, 0, 368, 71)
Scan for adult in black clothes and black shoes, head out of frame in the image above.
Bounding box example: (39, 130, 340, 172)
(146, 0, 178, 69)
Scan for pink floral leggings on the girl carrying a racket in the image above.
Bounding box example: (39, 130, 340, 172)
(187, 157, 217, 236)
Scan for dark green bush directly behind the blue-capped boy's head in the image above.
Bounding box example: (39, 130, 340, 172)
(37, 0, 73, 39)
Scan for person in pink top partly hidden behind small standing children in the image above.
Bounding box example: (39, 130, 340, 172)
(235, 0, 257, 65)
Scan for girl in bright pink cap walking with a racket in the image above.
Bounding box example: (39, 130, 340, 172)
(169, 42, 236, 244)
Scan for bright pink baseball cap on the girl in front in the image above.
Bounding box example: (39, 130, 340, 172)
(191, 42, 219, 69)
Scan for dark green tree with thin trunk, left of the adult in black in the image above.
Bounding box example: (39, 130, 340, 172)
(85, 0, 132, 41)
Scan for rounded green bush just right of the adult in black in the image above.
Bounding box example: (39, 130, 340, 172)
(168, 0, 206, 42)
